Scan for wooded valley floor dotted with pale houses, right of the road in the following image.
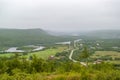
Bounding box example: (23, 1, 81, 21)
(78, 38, 120, 52)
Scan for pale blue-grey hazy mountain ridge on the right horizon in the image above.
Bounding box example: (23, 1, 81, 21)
(48, 30, 120, 39)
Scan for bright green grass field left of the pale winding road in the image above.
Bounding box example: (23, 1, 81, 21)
(0, 46, 67, 59)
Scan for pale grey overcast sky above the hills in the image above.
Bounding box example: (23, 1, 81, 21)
(0, 0, 120, 31)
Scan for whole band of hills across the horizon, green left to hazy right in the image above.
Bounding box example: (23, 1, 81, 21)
(0, 29, 120, 47)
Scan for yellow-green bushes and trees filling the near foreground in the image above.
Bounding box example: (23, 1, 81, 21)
(0, 55, 120, 80)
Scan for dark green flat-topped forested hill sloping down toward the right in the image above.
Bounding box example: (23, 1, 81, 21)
(0, 29, 75, 46)
